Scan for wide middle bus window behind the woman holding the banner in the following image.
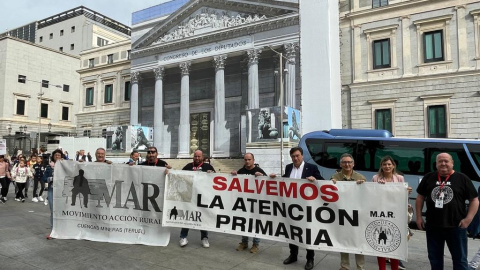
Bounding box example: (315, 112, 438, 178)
(359, 141, 425, 175)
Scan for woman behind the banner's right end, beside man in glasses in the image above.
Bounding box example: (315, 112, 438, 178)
(372, 156, 405, 270)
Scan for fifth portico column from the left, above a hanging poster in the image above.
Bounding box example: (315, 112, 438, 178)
(247, 49, 262, 109)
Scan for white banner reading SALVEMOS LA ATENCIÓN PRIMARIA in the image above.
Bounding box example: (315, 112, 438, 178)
(163, 170, 408, 260)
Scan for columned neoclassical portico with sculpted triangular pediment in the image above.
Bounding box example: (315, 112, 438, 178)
(130, 0, 301, 158)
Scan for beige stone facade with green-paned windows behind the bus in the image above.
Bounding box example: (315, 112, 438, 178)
(340, 0, 480, 139)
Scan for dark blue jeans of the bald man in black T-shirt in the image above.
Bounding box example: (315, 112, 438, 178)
(426, 224, 468, 270)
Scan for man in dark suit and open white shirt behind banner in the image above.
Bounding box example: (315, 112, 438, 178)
(270, 147, 324, 270)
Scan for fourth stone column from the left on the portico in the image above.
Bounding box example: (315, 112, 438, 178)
(213, 55, 229, 157)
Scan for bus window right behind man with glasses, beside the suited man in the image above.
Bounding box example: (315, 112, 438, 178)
(322, 140, 356, 169)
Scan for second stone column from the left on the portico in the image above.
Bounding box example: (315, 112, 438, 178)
(153, 67, 165, 154)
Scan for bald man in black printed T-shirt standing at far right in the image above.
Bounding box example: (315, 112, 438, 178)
(415, 153, 478, 270)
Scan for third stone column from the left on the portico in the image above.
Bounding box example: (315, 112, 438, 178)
(177, 61, 191, 158)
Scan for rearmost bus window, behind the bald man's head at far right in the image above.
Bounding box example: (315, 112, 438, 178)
(430, 143, 478, 181)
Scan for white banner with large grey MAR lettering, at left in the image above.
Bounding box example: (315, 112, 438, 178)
(51, 161, 170, 246)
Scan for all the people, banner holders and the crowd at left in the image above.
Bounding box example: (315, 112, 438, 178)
(0, 146, 479, 270)
